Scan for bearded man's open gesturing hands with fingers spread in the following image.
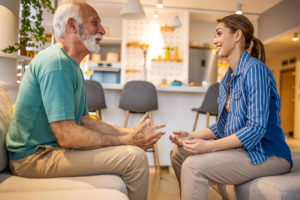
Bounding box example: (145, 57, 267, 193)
(123, 116, 166, 151)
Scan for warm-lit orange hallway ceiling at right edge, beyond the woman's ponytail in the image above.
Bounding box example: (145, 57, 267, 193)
(265, 31, 300, 57)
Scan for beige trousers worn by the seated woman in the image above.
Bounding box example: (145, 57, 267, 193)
(171, 146, 291, 200)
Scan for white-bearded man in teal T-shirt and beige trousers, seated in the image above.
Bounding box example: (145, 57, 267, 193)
(7, 1, 165, 200)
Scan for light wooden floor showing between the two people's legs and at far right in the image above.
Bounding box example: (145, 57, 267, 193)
(148, 137, 300, 200)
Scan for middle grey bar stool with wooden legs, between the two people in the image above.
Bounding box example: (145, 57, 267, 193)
(119, 81, 162, 178)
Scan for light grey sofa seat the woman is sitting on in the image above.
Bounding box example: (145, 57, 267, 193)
(212, 152, 300, 200)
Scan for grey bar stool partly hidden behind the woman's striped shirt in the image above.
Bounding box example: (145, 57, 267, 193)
(192, 83, 219, 131)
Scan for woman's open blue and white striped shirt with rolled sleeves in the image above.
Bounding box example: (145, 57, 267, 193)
(208, 51, 292, 165)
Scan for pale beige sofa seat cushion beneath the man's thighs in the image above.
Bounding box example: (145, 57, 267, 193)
(0, 172, 127, 195)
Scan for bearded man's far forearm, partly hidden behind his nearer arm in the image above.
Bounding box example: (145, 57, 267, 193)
(81, 118, 130, 136)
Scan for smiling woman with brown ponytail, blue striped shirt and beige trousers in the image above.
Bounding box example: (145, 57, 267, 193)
(170, 15, 292, 200)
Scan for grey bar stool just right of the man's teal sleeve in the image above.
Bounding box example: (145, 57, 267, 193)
(84, 80, 107, 121)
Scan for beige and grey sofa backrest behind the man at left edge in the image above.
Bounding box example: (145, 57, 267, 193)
(0, 85, 12, 172)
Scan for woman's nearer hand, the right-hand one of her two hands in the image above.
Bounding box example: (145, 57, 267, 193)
(183, 139, 214, 155)
